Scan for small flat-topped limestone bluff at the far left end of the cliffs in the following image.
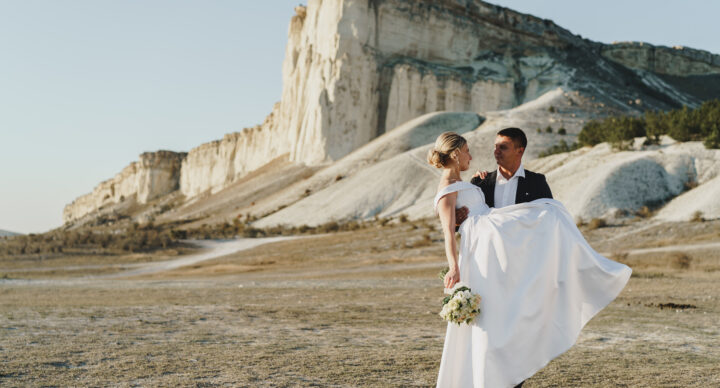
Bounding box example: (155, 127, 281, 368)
(63, 151, 186, 222)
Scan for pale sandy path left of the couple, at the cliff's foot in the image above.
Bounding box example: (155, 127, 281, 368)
(97, 236, 300, 279)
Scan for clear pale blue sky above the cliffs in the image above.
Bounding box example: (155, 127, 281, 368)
(0, 0, 720, 233)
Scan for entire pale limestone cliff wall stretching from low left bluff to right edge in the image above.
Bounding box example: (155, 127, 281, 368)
(65, 0, 720, 224)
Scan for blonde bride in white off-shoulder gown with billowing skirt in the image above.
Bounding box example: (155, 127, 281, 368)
(428, 132, 631, 388)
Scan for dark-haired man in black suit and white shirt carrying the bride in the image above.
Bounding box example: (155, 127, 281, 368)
(455, 128, 552, 388)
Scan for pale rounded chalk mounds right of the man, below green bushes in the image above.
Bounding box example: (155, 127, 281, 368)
(529, 138, 720, 221)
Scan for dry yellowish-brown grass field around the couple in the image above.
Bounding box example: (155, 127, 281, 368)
(0, 221, 720, 388)
